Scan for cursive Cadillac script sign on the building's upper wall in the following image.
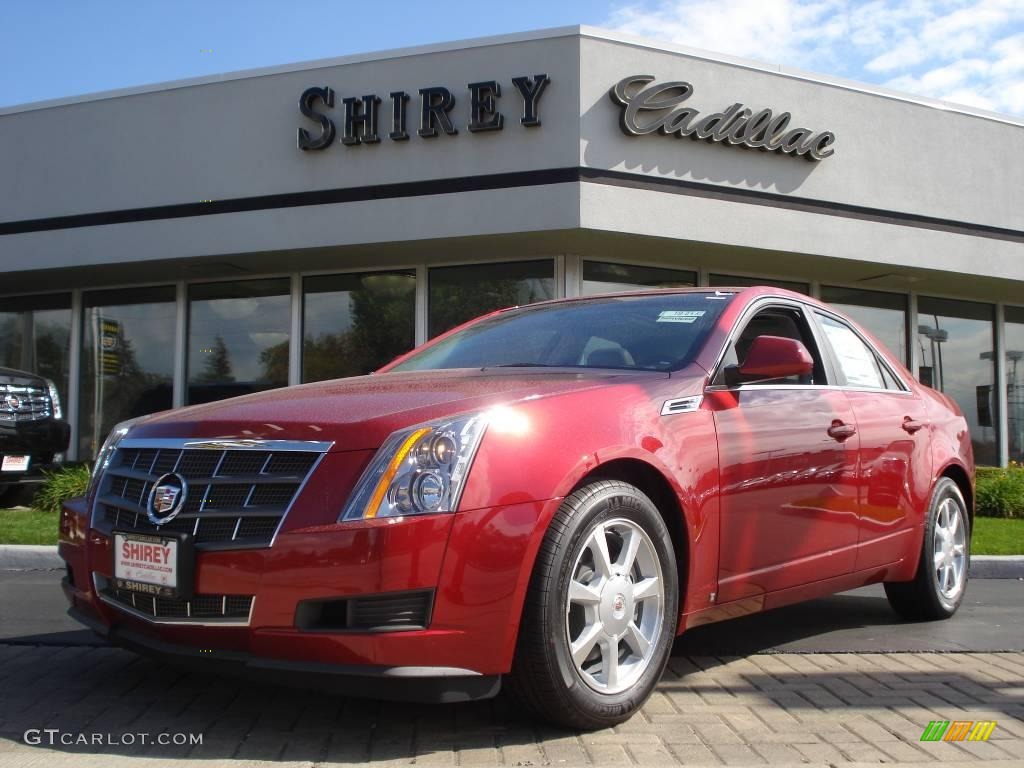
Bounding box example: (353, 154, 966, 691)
(609, 75, 836, 161)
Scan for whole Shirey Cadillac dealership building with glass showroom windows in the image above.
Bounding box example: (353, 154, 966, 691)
(0, 28, 1024, 465)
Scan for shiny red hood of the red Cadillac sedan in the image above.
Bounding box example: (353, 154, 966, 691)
(129, 369, 669, 451)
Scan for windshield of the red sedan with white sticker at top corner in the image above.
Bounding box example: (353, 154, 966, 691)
(391, 291, 732, 371)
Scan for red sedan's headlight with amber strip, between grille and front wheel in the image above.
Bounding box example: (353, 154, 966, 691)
(338, 414, 487, 522)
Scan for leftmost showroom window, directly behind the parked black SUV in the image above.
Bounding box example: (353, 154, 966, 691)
(0, 294, 71, 411)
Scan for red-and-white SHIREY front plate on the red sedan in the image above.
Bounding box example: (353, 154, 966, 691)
(114, 530, 191, 598)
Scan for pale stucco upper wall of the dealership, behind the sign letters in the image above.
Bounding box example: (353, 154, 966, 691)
(0, 29, 1024, 293)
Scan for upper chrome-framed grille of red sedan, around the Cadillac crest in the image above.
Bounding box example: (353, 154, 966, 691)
(93, 440, 323, 549)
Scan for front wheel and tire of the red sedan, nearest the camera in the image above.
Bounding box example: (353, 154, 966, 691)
(509, 480, 679, 729)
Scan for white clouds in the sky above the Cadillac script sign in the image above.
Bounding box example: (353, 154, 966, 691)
(606, 0, 1024, 115)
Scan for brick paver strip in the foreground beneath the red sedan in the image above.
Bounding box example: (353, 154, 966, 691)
(0, 644, 1024, 768)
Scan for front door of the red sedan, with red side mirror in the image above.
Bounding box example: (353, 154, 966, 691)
(707, 304, 859, 603)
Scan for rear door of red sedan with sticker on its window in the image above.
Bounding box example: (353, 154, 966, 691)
(814, 310, 932, 570)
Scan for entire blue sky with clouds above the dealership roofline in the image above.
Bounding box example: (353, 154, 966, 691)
(0, 0, 1024, 116)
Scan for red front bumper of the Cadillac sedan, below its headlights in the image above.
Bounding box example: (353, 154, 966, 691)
(59, 502, 550, 700)
